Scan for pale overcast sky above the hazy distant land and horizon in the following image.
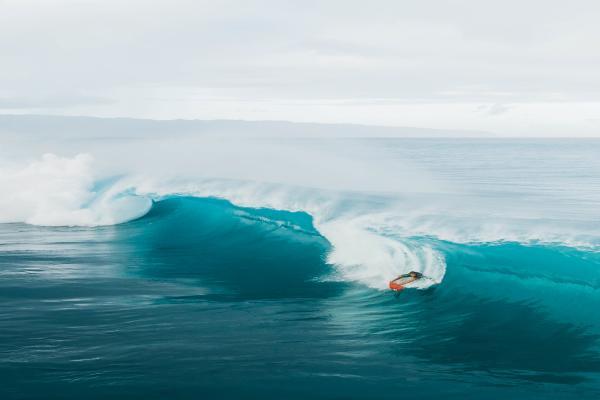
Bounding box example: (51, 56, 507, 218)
(0, 0, 600, 137)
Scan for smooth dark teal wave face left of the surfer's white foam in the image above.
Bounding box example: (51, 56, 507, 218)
(129, 197, 331, 299)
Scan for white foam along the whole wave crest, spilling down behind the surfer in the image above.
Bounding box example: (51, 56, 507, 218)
(0, 154, 600, 289)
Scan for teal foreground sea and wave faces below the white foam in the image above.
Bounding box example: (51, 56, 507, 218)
(0, 196, 600, 399)
